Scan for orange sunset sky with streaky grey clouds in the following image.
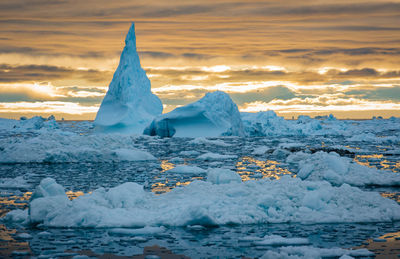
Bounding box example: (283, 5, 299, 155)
(0, 0, 400, 119)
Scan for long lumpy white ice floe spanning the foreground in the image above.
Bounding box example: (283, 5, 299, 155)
(16, 176, 400, 228)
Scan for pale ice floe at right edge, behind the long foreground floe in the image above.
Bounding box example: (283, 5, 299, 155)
(287, 151, 400, 186)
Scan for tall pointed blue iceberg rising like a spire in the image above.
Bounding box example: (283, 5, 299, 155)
(94, 23, 163, 134)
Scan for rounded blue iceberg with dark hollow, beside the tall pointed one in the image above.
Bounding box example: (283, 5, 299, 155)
(144, 91, 244, 137)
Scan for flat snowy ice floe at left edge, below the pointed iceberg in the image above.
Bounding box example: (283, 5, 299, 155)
(0, 133, 156, 163)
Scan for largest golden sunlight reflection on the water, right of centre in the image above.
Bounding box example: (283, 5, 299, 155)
(236, 157, 292, 181)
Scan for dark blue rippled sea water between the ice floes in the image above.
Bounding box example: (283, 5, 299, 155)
(0, 122, 400, 258)
